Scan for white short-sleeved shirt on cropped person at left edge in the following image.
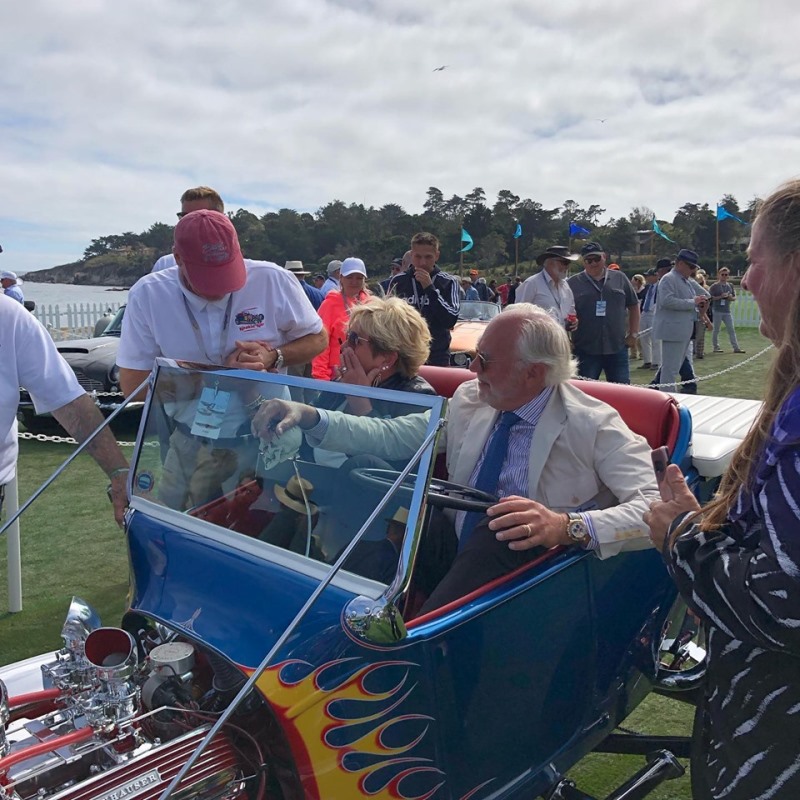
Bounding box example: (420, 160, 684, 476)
(0, 295, 83, 485)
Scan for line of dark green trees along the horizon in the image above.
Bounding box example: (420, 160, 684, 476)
(83, 186, 757, 275)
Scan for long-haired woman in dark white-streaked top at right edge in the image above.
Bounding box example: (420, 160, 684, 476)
(644, 180, 800, 800)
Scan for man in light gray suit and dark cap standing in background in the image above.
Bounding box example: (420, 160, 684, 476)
(653, 249, 708, 392)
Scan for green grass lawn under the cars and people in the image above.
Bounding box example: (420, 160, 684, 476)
(0, 328, 774, 800)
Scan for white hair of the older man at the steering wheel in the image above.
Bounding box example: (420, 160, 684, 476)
(497, 303, 577, 386)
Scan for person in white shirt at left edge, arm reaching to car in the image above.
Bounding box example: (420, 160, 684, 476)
(0, 295, 128, 525)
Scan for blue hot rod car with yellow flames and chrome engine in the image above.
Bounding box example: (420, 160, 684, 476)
(0, 361, 756, 800)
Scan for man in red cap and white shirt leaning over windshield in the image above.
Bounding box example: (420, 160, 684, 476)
(117, 209, 328, 509)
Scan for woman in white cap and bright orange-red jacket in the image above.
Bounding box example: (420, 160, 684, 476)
(311, 258, 371, 381)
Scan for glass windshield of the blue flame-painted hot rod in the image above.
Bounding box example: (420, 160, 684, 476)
(132, 361, 444, 583)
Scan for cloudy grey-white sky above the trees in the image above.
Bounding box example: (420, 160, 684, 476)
(0, 0, 800, 272)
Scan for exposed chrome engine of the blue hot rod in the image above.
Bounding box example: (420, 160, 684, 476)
(0, 598, 266, 800)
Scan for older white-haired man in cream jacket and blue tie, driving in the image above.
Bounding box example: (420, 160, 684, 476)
(253, 303, 658, 610)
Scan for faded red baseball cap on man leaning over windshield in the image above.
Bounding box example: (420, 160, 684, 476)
(174, 208, 247, 296)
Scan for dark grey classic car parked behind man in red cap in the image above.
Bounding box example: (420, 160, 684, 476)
(17, 305, 133, 433)
